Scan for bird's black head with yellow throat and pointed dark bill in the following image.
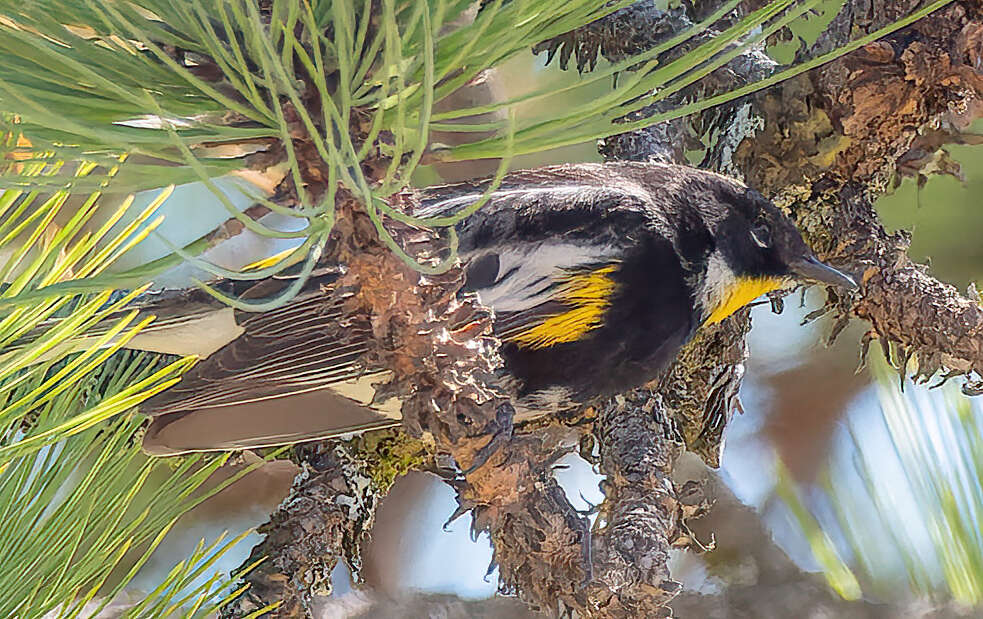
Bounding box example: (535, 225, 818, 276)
(704, 183, 857, 323)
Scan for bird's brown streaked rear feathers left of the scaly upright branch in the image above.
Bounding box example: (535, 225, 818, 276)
(141, 286, 398, 455)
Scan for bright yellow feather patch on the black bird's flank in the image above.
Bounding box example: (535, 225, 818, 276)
(508, 266, 617, 350)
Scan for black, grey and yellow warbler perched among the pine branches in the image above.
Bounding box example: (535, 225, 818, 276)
(135, 162, 856, 454)
